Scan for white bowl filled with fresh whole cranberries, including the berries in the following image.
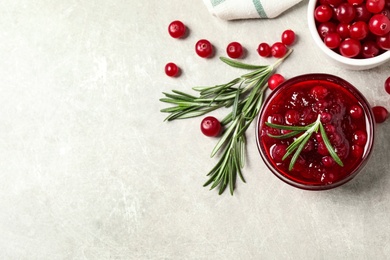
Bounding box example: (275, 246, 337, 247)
(307, 0, 390, 70)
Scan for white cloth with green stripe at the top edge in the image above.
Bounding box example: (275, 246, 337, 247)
(203, 0, 302, 20)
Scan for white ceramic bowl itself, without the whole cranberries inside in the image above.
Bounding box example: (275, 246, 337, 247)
(307, 0, 390, 70)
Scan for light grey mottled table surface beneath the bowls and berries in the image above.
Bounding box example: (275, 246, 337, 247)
(0, 0, 390, 259)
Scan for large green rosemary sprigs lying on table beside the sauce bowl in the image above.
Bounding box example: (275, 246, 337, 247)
(160, 50, 292, 195)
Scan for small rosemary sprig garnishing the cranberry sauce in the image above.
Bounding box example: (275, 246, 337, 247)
(265, 115, 344, 171)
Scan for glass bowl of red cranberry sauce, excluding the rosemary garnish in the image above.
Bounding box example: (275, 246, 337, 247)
(256, 74, 375, 190)
